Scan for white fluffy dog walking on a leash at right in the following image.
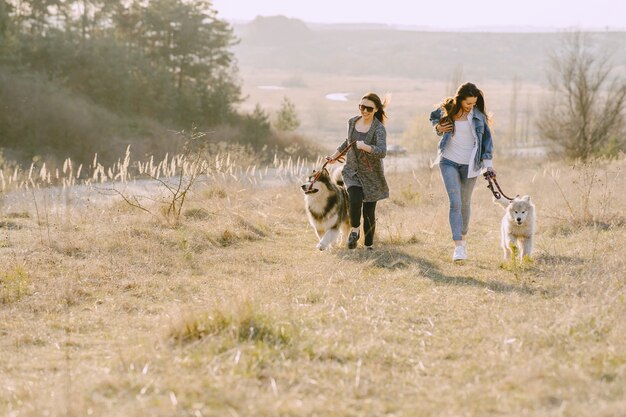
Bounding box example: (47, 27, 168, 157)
(498, 195, 535, 260)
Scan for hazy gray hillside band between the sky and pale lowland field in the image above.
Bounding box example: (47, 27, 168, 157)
(234, 16, 626, 82)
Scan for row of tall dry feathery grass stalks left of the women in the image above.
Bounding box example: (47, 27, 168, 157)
(0, 141, 312, 197)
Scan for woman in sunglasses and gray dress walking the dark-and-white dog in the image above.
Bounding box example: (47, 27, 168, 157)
(326, 93, 389, 250)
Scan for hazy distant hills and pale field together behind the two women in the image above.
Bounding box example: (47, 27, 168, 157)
(234, 16, 626, 156)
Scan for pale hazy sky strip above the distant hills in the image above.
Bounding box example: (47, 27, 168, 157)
(213, 0, 626, 30)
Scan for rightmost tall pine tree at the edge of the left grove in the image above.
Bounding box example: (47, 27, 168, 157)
(140, 0, 240, 124)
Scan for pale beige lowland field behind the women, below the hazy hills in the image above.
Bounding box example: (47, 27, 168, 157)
(236, 68, 544, 150)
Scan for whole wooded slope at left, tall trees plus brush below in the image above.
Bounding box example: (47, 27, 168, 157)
(0, 0, 312, 166)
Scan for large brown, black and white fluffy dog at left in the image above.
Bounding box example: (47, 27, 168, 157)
(300, 168, 350, 250)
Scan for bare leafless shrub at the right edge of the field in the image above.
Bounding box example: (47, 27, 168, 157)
(537, 32, 626, 161)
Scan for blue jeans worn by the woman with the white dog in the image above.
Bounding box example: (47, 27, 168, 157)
(439, 158, 477, 240)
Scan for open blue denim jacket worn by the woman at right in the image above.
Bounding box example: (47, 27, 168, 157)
(430, 107, 493, 178)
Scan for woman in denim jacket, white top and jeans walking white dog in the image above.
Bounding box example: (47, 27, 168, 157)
(430, 83, 493, 261)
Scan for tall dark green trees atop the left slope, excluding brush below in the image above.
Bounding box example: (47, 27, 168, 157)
(0, 0, 240, 124)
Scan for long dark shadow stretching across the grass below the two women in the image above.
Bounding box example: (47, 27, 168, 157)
(337, 247, 545, 295)
